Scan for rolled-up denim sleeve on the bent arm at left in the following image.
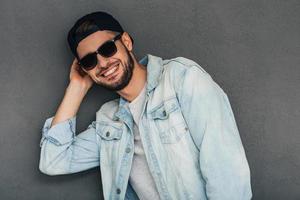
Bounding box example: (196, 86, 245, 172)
(39, 116, 100, 175)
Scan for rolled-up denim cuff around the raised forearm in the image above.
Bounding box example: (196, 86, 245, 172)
(40, 116, 76, 147)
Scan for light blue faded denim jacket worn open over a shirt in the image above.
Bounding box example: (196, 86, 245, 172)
(39, 54, 252, 200)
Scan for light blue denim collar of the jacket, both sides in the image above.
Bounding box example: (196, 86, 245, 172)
(114, 54, 163, 123)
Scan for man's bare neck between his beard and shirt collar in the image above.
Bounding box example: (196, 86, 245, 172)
(117, 59, 147, 102)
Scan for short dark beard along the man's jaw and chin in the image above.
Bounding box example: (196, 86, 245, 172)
(98, 48, 134, 91)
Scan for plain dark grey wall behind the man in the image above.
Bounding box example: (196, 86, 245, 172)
(0, 0, 300, 200)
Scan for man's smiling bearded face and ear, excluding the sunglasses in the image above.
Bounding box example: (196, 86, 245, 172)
(77, 31, 134, 91)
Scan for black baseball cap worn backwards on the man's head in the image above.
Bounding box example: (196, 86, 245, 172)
(68, 11, 133, 59)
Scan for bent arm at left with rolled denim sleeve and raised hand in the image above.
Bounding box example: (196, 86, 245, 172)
(39, 59, 99, 175)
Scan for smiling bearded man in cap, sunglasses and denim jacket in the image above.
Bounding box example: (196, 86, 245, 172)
(39, 12, 252, 200)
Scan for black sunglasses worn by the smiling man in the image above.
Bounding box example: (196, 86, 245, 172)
(78, 33, 122, 70)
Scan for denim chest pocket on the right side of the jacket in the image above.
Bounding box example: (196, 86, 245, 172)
(149, 97, 188, 144)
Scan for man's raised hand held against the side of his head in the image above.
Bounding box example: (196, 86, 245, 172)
(70, 58, 94, 90)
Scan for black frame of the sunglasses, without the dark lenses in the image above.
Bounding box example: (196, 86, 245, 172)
(78, 33, 123, 71)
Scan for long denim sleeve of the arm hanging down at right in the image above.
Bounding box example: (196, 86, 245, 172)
(178, 66, 252, 200)
